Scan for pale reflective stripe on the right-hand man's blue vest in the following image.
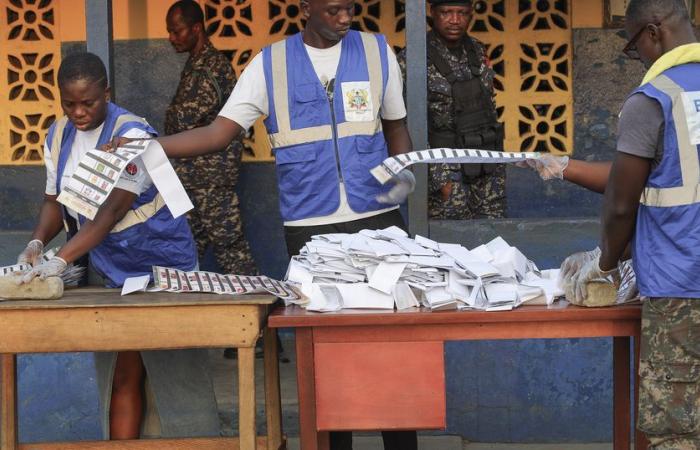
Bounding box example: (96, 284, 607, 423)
(640, 75, 700, 207)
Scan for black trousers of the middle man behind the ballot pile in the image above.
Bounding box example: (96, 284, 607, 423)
(284, 209, 418, 450)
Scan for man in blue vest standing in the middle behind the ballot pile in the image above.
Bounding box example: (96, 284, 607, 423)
(106, 0, 417, 450)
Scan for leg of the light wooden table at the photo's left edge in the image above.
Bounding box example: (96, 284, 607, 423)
(0, 353, 18, 450)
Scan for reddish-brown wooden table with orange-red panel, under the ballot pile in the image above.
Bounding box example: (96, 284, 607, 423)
(268, 302, 646, 450)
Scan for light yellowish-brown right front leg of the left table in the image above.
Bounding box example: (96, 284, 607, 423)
(237, 347, 257, 450)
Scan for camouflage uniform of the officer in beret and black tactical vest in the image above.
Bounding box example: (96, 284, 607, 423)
(398, 31, 506, 220)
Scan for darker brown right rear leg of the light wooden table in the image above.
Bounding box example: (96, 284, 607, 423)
(263, 327, 282, 450)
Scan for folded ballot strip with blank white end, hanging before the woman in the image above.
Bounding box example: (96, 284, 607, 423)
(58, 139, 193, 220)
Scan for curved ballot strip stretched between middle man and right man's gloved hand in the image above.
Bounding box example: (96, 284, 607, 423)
(371, 148, 538, 184)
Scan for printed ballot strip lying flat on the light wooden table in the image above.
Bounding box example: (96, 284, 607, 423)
(153, 266, 302, 302)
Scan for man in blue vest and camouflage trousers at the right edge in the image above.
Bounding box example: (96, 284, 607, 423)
(570, 0, 700, 444)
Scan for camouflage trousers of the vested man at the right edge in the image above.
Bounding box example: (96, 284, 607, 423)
(638, 298, 700, 450)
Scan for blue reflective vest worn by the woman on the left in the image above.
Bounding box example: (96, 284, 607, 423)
(46, 103, 197, 287)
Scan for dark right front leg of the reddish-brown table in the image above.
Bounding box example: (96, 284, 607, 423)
(613, 336, 632, 450)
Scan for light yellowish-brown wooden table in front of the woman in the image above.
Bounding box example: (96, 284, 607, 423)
(0, 288, 284, 450)
